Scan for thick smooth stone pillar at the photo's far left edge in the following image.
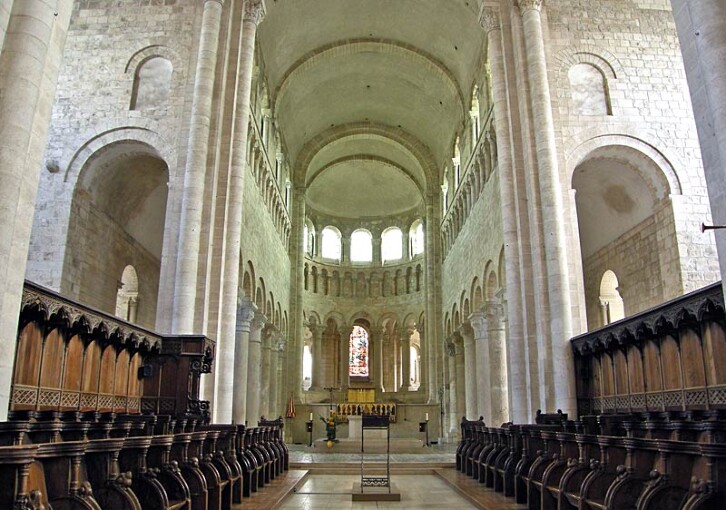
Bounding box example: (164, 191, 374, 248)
(0, 0, 73, 420)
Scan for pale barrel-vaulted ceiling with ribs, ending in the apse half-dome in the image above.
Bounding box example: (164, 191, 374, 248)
(258, 0, 485, 217)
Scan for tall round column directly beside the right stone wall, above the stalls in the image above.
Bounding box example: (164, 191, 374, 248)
(519, 0, 577, 414)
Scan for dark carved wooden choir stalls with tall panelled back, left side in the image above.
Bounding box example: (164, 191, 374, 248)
(0, 282, 289, 510)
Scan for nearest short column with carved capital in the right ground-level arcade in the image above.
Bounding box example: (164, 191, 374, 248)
(486, 302, 509, 427)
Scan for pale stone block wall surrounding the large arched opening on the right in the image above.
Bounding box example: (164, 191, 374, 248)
(543, 0, 719, 298)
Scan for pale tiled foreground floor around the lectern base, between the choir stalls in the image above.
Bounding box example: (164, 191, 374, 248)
(280, 474, 477, 510)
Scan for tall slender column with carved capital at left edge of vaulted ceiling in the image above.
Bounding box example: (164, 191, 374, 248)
(214, 0, 265, 423)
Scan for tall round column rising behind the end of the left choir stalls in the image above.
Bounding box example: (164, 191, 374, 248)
(171, 0, 224, 334)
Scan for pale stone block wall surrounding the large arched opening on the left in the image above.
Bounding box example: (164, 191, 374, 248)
(26, 0, 202, 298)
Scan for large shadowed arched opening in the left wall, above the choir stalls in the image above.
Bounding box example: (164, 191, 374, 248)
(61, 140, 169, 328)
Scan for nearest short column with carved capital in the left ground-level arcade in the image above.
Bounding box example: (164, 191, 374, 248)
(235, 298, 257, 424)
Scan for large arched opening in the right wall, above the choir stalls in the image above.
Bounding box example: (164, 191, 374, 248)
(572, 145, 682, 328)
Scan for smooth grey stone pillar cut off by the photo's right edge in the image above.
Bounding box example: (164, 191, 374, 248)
(671, 0, 726, 288)
